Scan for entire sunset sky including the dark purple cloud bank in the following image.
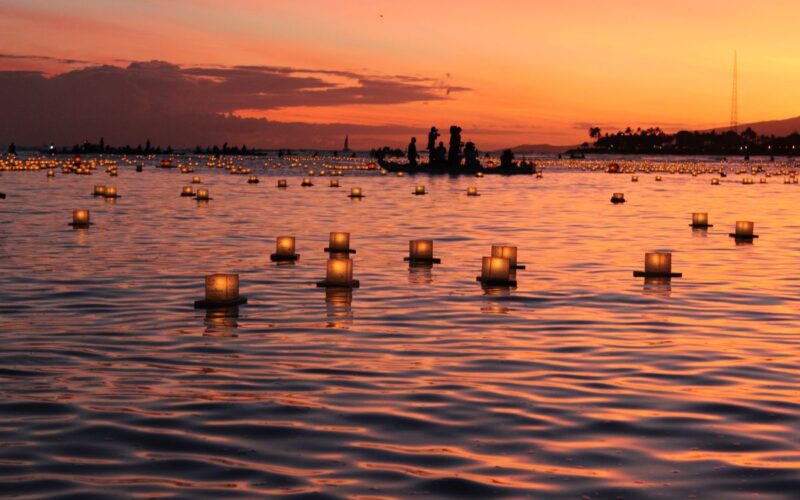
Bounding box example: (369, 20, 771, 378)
(0, 0, 800, 149)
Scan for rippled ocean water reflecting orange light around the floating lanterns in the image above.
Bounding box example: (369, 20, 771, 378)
(0, 158, 800, 499)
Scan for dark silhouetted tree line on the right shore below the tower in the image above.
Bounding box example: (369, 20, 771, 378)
(570, 127, 800, 156)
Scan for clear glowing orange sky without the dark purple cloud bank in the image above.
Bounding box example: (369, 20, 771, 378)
(0, 0, 800, 148)
